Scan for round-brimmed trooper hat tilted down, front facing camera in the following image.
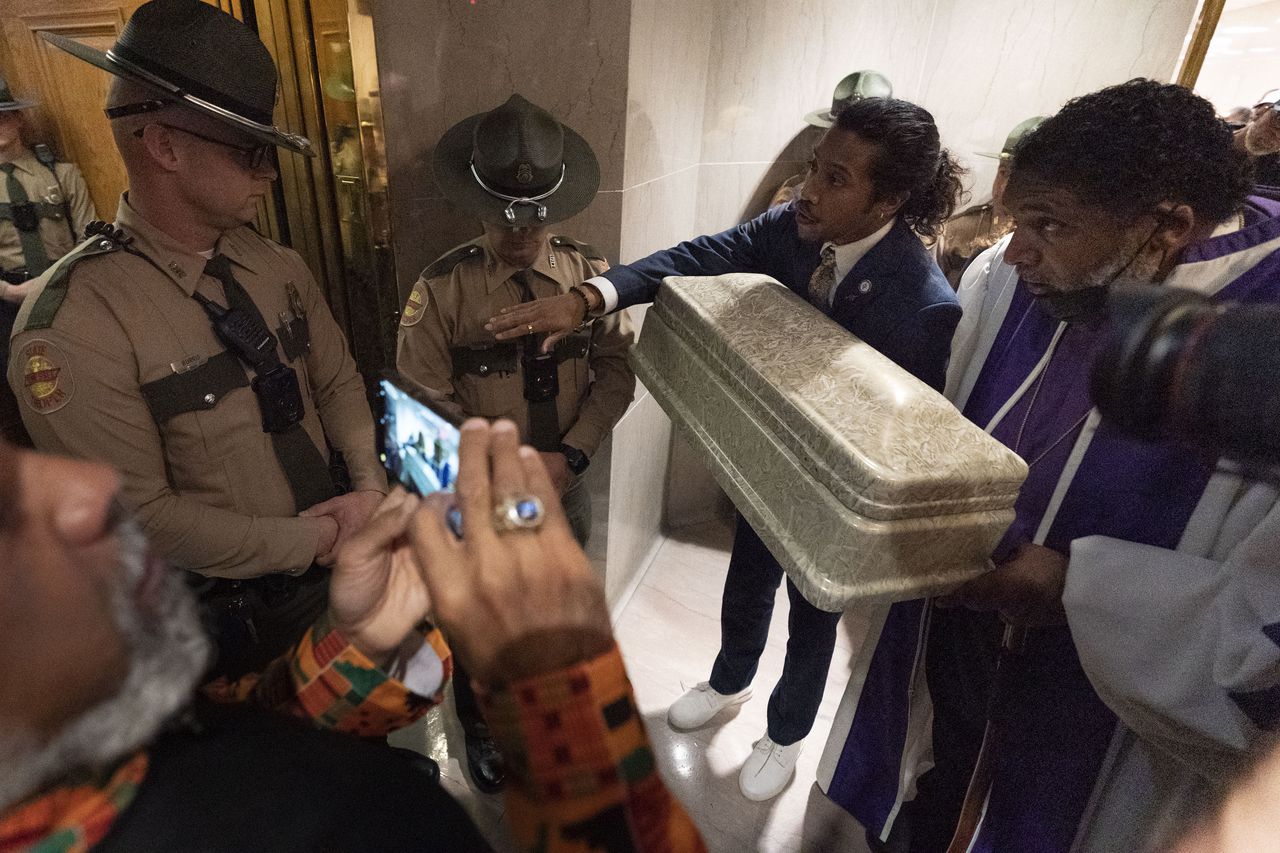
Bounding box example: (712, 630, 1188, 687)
(433, 95, 600, 227)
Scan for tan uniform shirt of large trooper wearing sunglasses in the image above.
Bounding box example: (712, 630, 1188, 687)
(9, 197, 387, 578)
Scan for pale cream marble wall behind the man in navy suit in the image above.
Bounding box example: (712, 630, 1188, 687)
(698, 0, 1196, 231)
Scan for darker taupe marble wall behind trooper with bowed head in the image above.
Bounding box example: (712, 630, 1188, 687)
(371, 0, 631, 300)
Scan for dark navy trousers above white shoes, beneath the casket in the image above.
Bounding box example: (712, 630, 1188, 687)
(710, 516, 841, 745)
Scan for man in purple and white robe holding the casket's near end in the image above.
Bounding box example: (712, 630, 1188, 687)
(819, 79, 1280, 853)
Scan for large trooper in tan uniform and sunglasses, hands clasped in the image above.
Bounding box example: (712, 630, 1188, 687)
(8, 0, 387, 674)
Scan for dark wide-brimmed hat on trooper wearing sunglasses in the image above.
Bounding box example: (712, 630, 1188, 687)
(40, 0, 315, 155)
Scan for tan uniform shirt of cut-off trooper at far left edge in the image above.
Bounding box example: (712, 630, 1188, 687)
(0, 152, 97, 270)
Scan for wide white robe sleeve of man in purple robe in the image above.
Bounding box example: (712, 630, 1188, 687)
(1062, 474, 1280, 779)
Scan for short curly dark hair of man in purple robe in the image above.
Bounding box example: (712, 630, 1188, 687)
(1009, 78, 1253, 222)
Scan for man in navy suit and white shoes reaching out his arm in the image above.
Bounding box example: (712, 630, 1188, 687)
(488, 99, 960, 800)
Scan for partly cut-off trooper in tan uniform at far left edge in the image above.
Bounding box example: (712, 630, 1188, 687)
(0, 78, 97, 444)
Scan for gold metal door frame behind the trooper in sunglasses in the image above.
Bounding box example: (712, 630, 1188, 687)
(249, 0, 399, 377)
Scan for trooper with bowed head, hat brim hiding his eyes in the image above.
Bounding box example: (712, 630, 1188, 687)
(397, 95, 635, 792)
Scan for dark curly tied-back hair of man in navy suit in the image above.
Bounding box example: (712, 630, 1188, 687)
(836, 97, 964, 237)
